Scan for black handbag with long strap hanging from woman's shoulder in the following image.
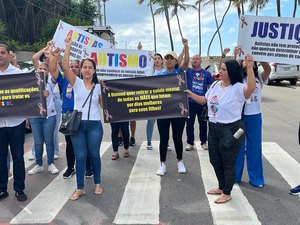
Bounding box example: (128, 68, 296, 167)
(59, 86, 95, 135)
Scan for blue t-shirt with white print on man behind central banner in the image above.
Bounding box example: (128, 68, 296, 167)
(186, 68, 213, 102)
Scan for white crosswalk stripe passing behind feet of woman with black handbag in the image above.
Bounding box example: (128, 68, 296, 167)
(10, 142, 111, 224)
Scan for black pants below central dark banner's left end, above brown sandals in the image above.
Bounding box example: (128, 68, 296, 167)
(110, 122, 129, 152)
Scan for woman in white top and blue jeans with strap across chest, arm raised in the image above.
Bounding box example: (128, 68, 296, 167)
(63, 37, 103, 201)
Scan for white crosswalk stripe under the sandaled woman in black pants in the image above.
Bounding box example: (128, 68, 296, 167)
(196, 142, 261, 225)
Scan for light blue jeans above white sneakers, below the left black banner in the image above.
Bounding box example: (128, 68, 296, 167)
(29, 116, 56, 166)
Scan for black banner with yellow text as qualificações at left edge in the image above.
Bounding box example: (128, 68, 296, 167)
(0, 72, 47, 117)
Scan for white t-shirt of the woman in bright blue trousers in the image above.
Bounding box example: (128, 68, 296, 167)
(244, 72, 264, 115)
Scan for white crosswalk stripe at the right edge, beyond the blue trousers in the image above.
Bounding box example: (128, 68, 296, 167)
(263, 142, 300, 190)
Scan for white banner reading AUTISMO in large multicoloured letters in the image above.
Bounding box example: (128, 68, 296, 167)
(85, 46, 154, 80)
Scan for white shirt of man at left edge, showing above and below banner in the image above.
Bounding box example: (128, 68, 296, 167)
(0, 64, 25, 128)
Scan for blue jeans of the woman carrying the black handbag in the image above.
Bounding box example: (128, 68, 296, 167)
(71, 120, 103, 189)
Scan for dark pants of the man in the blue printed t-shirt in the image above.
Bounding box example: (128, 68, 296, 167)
(186, 102, 207, 145)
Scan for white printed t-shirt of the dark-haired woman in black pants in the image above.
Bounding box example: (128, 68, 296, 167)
(205, 81, 246, 123)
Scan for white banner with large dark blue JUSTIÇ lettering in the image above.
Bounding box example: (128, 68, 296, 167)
(238, 16, 300, 65)
